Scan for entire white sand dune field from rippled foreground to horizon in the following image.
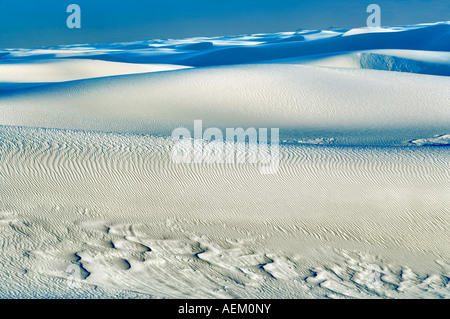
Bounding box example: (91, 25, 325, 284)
(0, 22, 450, 298)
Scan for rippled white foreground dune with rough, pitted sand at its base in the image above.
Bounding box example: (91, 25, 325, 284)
(0, 128, 450, 298)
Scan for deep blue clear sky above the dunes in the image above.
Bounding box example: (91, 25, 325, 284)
(0, 0, 450, 48)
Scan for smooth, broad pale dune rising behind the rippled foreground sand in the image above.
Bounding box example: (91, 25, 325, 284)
(0, 65, 450, 144)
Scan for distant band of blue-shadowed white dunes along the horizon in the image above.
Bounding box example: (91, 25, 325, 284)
(4, 22, 450, 67)
